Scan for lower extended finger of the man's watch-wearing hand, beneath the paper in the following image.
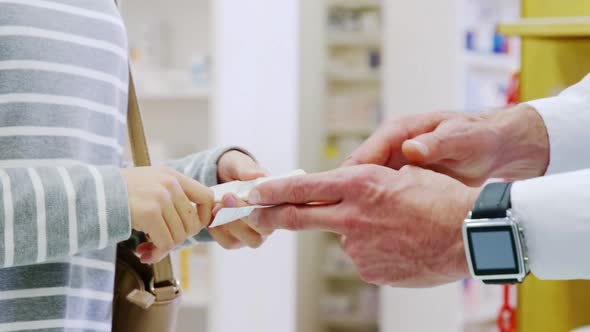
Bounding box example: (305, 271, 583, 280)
(248, 204, 347, 234)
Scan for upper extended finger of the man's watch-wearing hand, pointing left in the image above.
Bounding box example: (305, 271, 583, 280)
(248, 169, 347, 205)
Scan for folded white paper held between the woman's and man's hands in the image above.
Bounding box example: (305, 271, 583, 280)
(209, 169, 306, 228)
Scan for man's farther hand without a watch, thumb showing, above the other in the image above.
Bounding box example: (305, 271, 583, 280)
(344, 105, 549, 186)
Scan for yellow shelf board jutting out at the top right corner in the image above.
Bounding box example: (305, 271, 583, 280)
(498, 16, 590, 38)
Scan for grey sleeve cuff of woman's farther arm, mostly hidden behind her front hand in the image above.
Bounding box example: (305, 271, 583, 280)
(167, 146, 251, 243)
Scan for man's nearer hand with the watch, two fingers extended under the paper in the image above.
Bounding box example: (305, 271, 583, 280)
(249, 165, 479, 287)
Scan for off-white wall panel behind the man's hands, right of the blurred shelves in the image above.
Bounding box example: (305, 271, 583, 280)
(381, 0, 462, 332)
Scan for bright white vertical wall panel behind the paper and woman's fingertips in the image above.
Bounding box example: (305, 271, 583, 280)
(210, 0, 299, 332)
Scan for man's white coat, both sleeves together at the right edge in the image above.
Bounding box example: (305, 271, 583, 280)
(511, 75, 590, 279)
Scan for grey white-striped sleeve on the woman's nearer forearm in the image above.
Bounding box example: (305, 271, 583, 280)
(0, 165, 131, 267)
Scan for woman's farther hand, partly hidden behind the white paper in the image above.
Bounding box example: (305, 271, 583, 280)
(209, 150, 268, 249)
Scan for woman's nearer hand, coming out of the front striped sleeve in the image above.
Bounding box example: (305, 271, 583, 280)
(121, 167, 214, 264)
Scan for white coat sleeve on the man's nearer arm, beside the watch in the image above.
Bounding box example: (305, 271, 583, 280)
(511, 169, 590, 280)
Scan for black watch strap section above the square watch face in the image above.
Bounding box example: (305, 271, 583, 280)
(471, 182, 512, 219)
